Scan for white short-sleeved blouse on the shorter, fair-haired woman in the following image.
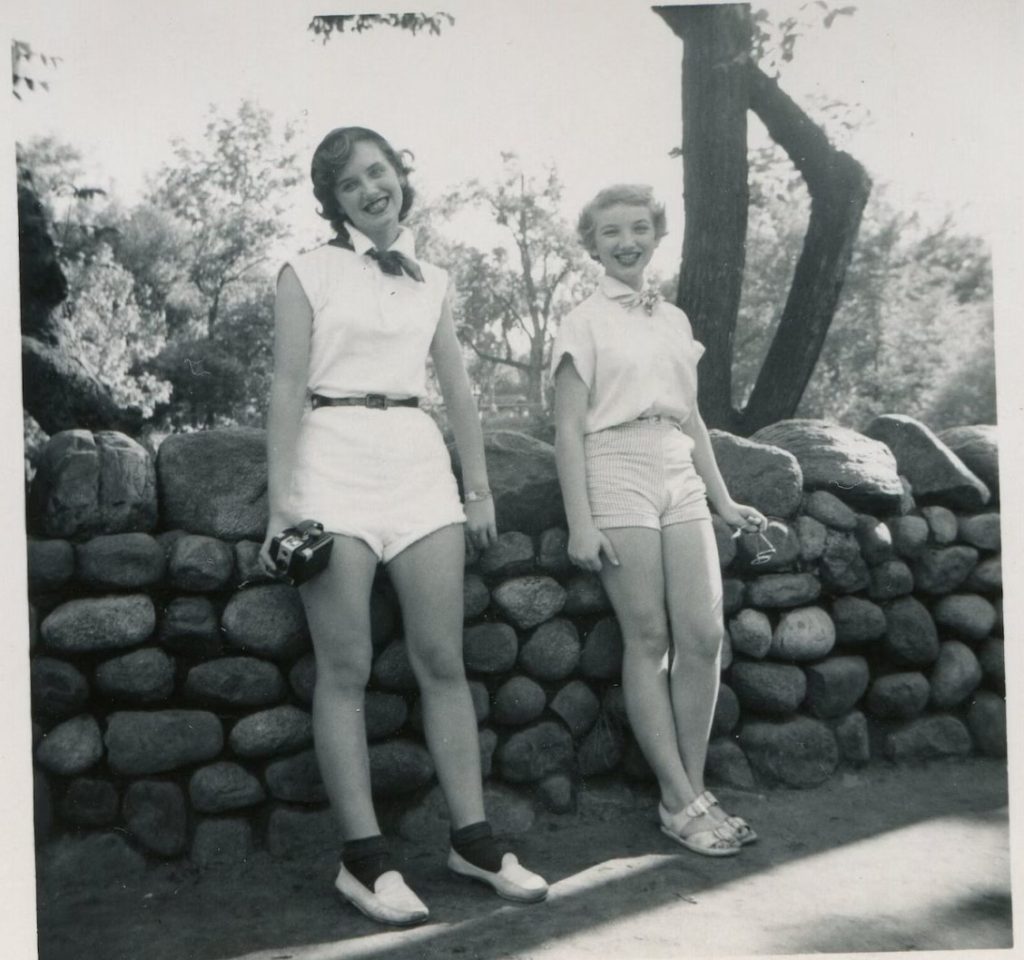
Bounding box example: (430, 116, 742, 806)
(551, 276, 705, 433)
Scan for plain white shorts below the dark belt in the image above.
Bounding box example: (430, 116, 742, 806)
(289, 406, 466, 563)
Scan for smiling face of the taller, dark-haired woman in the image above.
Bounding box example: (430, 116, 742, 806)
(334, 140, 402, 248)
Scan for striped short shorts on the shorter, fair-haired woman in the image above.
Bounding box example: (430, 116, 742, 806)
(584, 418, 711, 530)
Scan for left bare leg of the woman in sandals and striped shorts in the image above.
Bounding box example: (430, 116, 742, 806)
(601, 527, 696, 813)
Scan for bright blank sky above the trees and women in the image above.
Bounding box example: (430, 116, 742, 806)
(10, 0, 1020, 273)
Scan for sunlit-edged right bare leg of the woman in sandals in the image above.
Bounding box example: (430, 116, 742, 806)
(662, 520, 724, 798)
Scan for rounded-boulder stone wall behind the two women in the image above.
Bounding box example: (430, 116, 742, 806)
(29, 414, 1006, 865)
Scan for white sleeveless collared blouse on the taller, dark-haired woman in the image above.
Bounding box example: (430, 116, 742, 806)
(287, 227, 447, 399)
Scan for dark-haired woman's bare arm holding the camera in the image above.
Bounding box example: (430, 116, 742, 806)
(260, 266, 313, 567)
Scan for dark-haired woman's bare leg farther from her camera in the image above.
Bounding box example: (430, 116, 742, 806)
(388, 524, 484, 830)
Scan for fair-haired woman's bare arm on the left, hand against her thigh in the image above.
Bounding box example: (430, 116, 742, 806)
(555, 355, 618, 572)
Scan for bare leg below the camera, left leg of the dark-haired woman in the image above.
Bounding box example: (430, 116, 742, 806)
(299, 534, 380, 840)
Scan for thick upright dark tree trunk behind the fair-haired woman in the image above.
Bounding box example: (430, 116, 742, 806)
(654, 4, 751, 430)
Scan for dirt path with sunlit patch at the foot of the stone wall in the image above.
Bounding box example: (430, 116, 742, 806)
(39, 759, 1012, 960)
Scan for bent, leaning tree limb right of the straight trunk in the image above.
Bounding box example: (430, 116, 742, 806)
(739, 63, 871, 435)
